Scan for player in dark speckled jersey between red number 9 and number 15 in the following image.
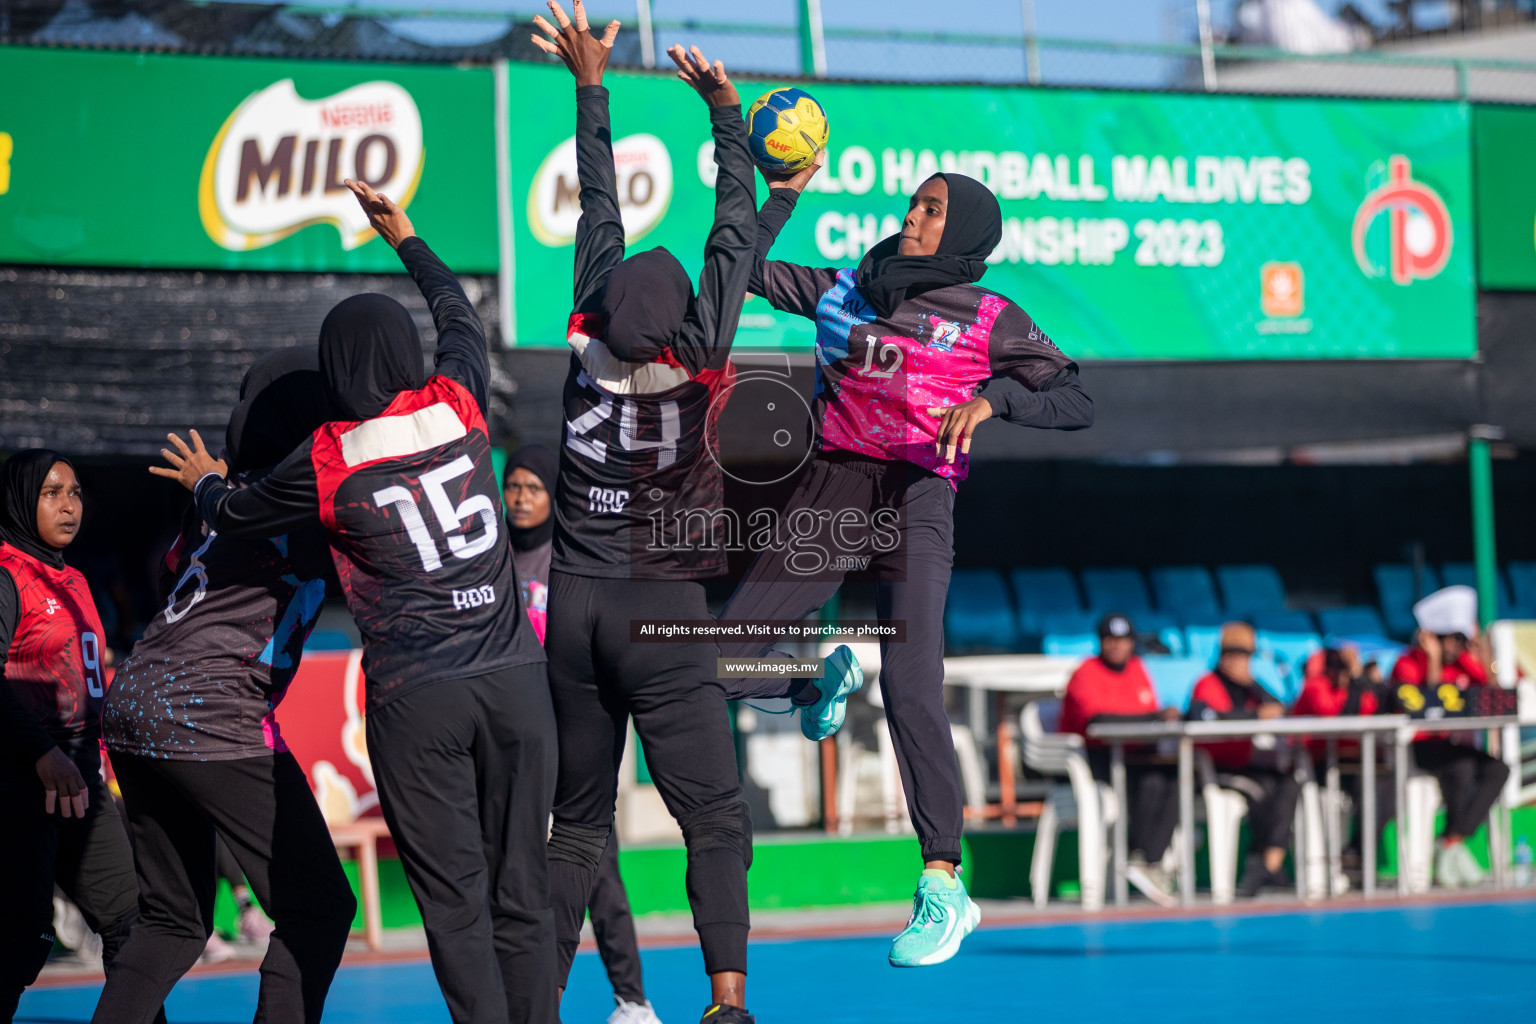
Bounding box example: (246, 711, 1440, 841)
(94, 348, 356, 1024)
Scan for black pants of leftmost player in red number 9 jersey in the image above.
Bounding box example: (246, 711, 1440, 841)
(0, 740, 164, 1024)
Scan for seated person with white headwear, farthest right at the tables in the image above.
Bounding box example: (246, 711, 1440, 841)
(1392, 586, 1510, 889)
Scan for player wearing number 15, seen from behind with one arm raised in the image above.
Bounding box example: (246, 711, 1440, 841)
(157, 183, 556, 1024)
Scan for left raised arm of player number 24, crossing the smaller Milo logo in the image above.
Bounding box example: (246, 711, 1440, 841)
(533, 0, 624, 312)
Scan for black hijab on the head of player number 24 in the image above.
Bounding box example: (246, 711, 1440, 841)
(601, 247, 693, 362)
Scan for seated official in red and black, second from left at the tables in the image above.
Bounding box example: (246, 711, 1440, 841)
(1189, 622, 1301, 897)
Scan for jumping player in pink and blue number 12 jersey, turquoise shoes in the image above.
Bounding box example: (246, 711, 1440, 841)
(720, 167, 1094, 967)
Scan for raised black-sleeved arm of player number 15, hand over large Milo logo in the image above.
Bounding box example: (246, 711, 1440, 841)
(347, 178, 490, 411)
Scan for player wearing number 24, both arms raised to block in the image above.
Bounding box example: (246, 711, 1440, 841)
(535, 3, 756, 1024)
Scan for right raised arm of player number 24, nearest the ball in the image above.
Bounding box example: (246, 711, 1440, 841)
(667, 46, 757, 373)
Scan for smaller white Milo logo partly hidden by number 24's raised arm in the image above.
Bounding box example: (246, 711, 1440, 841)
(528, 135, 673, 246)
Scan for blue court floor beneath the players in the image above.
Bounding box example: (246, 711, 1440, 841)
(15, 900, 1536, 1024)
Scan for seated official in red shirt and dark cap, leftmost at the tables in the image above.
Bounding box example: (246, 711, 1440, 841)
(1058, 614, 1178, 906)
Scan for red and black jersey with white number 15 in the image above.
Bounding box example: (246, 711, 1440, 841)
(310, 375, 544, 708)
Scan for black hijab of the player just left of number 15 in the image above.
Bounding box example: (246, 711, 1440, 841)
(224, 348, 341, 473)
